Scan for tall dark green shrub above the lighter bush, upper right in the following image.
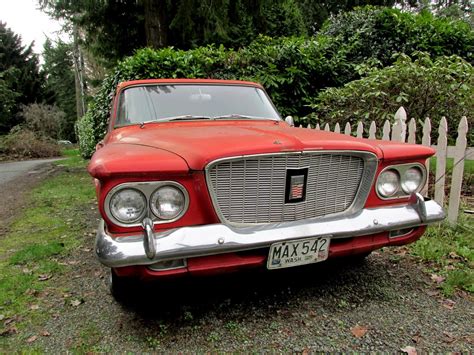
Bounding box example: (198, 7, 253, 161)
(319, 6, 474, 78)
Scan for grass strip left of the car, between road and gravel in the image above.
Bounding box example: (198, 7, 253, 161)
(0, 152, 95, 350)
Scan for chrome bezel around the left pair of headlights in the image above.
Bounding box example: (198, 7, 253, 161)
(103, 180, 190, 228)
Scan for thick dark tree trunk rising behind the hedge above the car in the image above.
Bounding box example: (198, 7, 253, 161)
(143, 0, 168, 48)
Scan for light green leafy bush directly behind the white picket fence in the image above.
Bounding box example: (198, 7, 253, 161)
(305, 52, 474, 144)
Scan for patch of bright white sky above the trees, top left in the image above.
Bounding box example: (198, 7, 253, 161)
(0, 0, 68, 54)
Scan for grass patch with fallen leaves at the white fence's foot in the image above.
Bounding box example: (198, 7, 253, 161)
(409, 217, 474, 296)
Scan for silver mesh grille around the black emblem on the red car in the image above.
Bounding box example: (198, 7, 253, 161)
(207, 152, 376, 224)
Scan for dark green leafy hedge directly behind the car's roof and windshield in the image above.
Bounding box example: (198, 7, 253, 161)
(77, 36, 323, 157)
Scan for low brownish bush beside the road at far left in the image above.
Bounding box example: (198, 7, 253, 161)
(0, 127, 60, 158)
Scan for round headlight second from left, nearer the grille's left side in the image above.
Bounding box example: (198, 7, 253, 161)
(150, 185, 187, 220)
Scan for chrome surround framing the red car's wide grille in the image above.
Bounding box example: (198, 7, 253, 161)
(204, 150, 378, 227)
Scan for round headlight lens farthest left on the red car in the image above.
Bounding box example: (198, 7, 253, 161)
(110, 188, 146, 224)
